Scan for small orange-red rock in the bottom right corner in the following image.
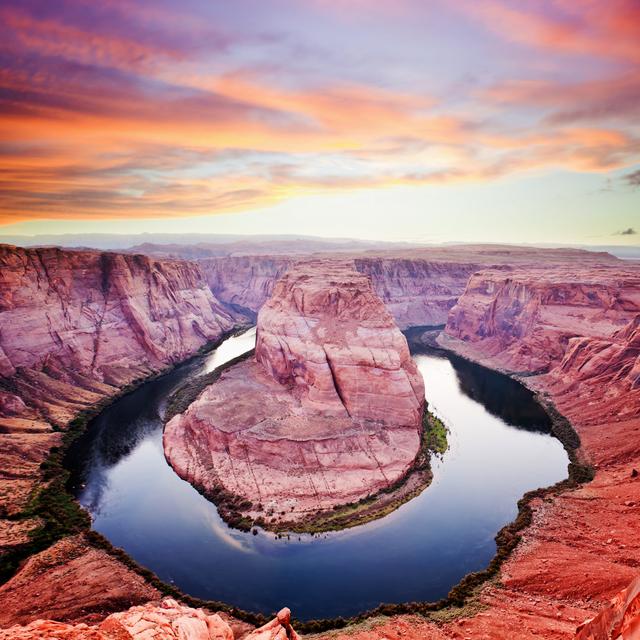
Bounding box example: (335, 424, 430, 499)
(576, 578, 640, 640)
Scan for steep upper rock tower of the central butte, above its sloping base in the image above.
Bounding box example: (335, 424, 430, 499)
(256, 262, 424, 427)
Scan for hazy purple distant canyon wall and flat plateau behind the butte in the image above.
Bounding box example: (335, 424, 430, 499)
(199, 245, 619, 329)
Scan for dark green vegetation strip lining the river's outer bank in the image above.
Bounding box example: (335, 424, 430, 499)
(0, 328, 593, 633)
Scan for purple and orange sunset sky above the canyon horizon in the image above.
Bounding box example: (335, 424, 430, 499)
(0, 0, 640, 245)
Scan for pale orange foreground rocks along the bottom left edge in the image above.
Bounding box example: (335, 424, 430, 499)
(0, 598, 298, 640)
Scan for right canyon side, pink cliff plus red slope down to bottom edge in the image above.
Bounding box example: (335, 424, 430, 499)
(364, 264, 640, 639)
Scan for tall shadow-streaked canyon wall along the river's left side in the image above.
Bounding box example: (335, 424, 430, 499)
(0, 245, 234, 576)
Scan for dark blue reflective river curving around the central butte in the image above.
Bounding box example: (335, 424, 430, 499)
(68, 329, 568, 620)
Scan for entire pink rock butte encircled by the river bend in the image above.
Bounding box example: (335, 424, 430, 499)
(164, 262, 424, 521)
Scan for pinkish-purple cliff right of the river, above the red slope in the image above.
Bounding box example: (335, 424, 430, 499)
(442, 266, 640, 374)
